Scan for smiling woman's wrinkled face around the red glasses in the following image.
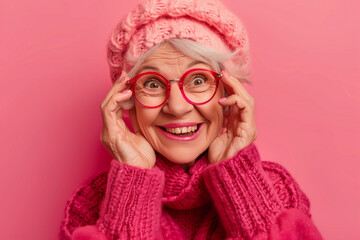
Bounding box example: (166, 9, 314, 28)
(130, 44, 224, 166)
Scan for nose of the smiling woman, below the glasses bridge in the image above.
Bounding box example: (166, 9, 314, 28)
(162, 82, 194, 118)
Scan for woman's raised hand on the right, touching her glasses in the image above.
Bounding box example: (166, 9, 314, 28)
(209, 71, 257, 163)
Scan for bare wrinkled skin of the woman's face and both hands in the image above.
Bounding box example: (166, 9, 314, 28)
(101, 45, 257, 169)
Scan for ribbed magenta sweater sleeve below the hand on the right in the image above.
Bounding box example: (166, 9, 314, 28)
(203, 144, 322, 240)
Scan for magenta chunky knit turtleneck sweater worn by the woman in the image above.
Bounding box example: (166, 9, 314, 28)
(60, 144, 322, 240)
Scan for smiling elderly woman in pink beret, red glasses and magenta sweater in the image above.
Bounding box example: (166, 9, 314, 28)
(60, 0, 322, 240)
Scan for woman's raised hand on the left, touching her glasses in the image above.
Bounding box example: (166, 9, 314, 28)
(100, 72, 156, 169)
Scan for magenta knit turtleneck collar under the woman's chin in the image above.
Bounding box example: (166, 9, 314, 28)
(155, 153, 211, 209)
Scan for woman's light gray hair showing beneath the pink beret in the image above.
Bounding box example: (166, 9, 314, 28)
(121, 38, 252, 109)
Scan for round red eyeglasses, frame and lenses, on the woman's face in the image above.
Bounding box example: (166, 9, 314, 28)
(127, 68, 222, 108)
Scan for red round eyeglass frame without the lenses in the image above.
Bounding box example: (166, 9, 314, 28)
(126, 68, 223, 108)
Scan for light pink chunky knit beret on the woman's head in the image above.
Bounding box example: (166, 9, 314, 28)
(107, 0, 249, 82)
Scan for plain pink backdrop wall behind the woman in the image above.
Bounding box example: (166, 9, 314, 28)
(0, 0, 360, 240)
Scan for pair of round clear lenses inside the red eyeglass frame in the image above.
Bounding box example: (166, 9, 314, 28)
(134, 70, 216, 107)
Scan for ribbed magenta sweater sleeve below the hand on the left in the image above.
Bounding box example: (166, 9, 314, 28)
(72, 160, 165, 240)
